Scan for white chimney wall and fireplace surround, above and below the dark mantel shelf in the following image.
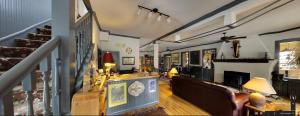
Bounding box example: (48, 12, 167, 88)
(215, 29, 300, 83)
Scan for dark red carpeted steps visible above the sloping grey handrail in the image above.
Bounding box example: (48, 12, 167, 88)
(0, 25, 51, 75)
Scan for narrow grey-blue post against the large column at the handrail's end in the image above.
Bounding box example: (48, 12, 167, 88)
(51, 48, 60, 116)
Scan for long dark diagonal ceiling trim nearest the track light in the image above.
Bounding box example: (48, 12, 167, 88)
(140, 0, 247, 48)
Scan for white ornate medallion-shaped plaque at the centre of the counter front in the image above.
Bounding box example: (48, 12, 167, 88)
(128, 81, 145, 97)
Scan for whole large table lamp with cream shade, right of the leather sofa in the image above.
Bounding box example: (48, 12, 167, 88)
(243, 77, 276, 108)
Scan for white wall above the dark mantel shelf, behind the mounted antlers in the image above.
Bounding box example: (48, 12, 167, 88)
(218, 29, 300, 59)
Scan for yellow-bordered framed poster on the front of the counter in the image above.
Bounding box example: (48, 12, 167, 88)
(108, 82, 127, 108)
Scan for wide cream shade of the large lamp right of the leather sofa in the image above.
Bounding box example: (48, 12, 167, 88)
(243, 77, 276, 95)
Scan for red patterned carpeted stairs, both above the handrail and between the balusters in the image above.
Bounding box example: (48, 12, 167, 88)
(0, 25, 51, 115)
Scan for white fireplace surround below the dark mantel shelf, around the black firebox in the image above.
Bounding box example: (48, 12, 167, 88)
(214, 60, 278, 83)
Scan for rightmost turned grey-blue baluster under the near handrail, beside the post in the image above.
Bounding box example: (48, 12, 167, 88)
(40, 55, 51, 115)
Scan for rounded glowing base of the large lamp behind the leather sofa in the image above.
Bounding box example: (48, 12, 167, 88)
(249, 93, 266, 108)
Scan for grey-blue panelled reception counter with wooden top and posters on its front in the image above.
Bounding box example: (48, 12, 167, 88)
(106, 73, 159, 115)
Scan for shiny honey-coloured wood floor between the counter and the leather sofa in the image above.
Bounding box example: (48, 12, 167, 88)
(158, 81, 209, 115)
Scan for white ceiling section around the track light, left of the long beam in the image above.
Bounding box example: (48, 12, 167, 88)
(90, 0, 234, 42)
